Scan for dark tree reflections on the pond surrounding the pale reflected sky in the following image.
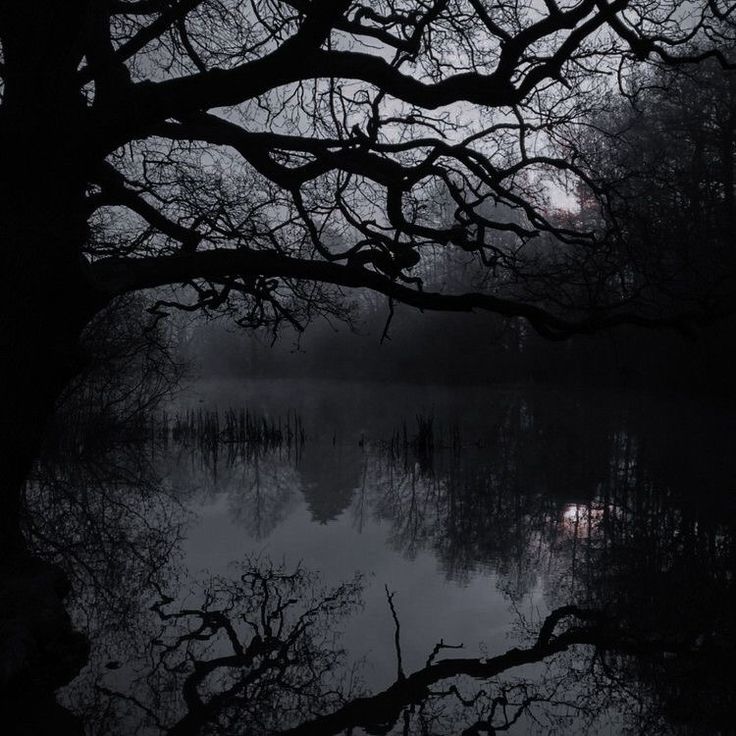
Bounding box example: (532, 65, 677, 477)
(18, 388, 736, 735)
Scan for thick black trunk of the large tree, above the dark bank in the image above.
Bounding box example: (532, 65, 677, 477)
(0, 0, 108, 547)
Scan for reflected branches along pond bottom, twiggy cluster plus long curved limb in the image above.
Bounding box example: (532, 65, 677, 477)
(86, 560, 732, 736)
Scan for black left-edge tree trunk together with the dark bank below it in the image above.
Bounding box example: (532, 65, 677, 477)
(0, 5, 105, 720)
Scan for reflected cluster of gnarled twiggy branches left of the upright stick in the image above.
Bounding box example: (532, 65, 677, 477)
(92, 560, 362, 735)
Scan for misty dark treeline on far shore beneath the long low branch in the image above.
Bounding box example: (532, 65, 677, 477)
(188, 298, 736, 396)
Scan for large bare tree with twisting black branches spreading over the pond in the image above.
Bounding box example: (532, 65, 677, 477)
(0, 0, 733, 543)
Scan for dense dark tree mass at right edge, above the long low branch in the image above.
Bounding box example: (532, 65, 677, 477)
(578, 56, 736, 312)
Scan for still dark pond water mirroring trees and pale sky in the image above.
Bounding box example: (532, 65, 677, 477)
(30, 381, 736, 734)
